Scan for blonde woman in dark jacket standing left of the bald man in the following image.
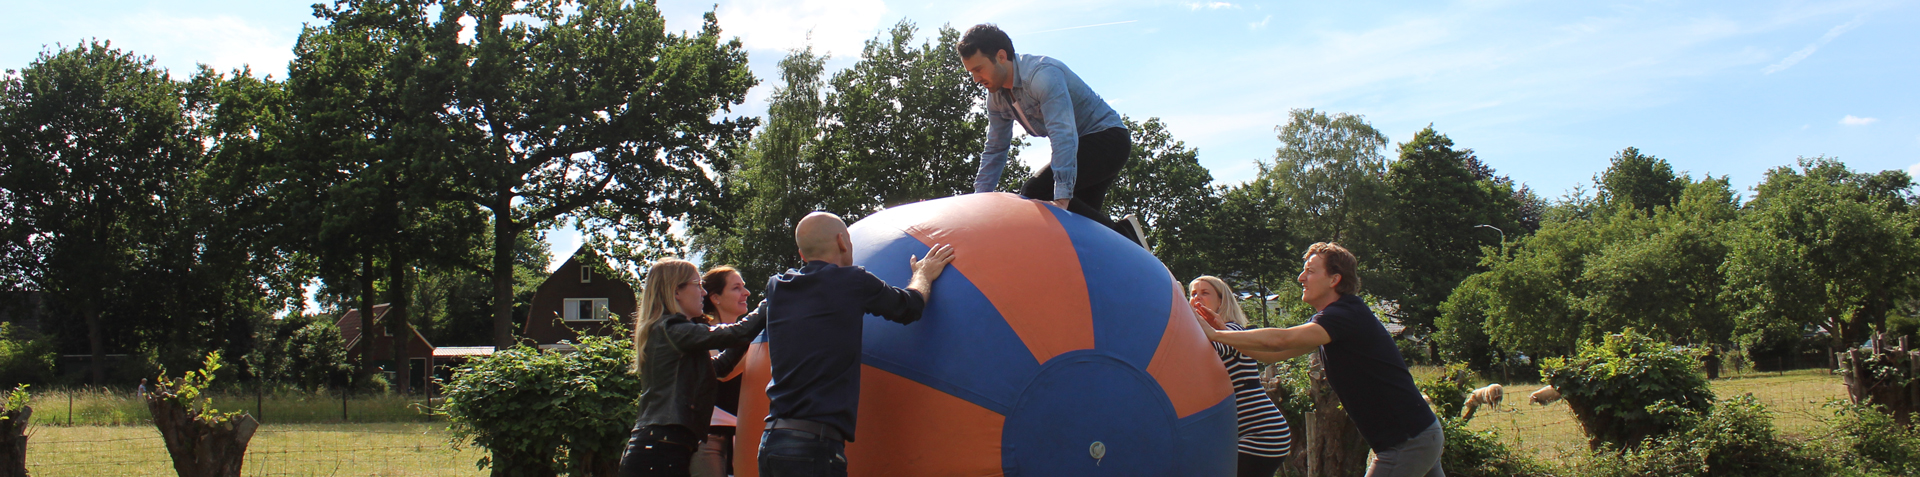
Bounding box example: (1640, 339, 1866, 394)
(620, 258, 766, 477)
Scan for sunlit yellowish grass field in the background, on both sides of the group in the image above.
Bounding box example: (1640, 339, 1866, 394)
(27, 367, 1845, 477)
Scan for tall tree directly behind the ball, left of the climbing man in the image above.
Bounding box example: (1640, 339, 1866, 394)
(695, 21, 1027, 289)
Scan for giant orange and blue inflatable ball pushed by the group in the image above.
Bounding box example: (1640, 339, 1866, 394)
(733, 194, 1236, 477)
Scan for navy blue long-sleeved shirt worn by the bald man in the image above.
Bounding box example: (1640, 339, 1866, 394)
(766, 262, 927, 442)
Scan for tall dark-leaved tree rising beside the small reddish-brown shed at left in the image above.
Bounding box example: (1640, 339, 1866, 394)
(288, 2, 484, 389)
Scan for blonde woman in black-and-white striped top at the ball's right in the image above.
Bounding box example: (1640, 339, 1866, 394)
(1187, 275, 1294, 477)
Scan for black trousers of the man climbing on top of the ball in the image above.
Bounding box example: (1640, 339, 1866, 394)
(1020, 127, 1133, 235)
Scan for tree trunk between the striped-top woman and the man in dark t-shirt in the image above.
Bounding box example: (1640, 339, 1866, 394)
(1308, 352, 1367, 477)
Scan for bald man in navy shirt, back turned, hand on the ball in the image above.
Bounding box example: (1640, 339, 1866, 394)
(758, 212, 954, 477)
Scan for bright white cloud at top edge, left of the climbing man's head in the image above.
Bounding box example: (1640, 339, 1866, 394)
(714, 0, 887, 58)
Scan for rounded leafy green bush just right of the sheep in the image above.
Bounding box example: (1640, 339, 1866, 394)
(1542, 329, 1713, 448)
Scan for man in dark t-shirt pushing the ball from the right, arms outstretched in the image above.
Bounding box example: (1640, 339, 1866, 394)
(1200, 242, 1446, 477)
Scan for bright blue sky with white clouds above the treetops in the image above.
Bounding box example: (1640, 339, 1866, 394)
(0, 0, 1920, 265)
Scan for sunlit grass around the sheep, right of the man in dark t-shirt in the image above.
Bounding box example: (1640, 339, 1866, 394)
(1459, 369, 1847, 465)
